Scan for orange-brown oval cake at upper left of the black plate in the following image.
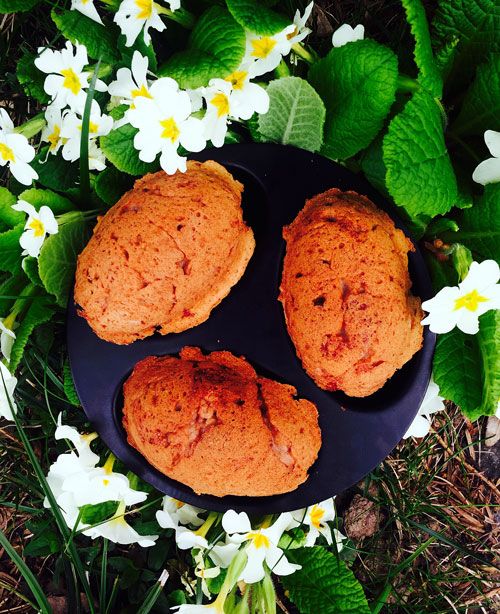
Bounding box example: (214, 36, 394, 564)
(75, 161, 255, 344)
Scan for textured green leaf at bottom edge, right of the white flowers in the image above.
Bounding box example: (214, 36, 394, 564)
(280, 548, 370, 614)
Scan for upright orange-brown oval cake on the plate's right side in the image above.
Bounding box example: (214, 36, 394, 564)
(280, 189, 423, 397)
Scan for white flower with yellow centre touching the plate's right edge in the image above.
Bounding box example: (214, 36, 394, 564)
(422, 260, 500, 335)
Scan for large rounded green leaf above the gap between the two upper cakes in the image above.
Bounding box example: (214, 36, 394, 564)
(309, 40, 398, 160)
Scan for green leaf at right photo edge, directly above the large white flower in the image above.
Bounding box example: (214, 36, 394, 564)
(443, 183, 500, 261)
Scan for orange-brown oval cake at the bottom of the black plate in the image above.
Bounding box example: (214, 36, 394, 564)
(123, 348, 321, 497)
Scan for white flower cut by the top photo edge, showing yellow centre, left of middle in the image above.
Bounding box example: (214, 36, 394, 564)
(113, 0, 181, 47)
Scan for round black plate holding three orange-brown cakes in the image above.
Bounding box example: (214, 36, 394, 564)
(68, 144, 435, 514)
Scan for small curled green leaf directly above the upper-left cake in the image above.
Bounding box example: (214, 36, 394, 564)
(100, 124, 159, 176)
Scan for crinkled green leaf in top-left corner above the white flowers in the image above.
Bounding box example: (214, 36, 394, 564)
(51, 10, 120, 64)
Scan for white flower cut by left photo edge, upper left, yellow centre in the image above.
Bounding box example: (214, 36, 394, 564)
(0, 109, 38, 185)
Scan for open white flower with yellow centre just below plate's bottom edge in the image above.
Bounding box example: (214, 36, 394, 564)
(222, 510, 301, 584)
